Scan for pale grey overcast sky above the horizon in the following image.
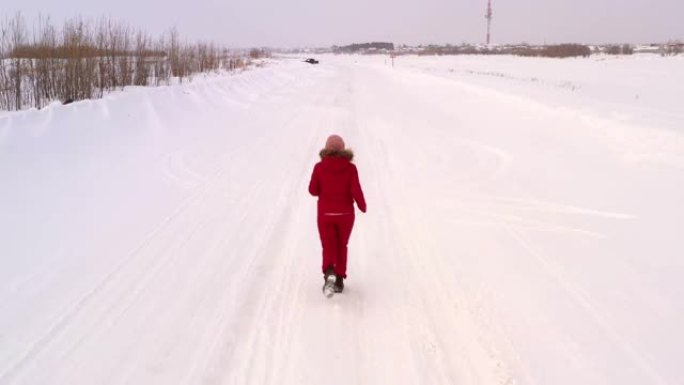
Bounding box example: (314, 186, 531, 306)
(0, 0, 684, 47)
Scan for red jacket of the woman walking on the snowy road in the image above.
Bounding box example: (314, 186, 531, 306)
(309, 156, 366, 215)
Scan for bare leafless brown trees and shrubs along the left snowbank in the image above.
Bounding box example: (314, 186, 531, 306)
(0, 14, 268, 110)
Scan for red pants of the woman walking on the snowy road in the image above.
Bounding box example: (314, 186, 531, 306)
(318, 214, 354, 278)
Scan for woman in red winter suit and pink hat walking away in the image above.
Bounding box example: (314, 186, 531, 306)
(309, 135, 366, 295)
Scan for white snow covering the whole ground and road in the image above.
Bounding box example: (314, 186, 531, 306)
(0, 55, 684, 385)
